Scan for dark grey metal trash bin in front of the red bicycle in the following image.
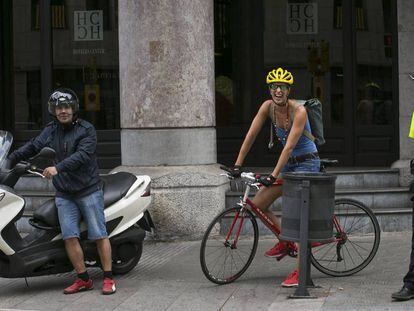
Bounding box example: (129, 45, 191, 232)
(280, 172, 336, 242)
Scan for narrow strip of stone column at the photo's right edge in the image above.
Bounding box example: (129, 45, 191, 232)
(392, 0, 414, 186)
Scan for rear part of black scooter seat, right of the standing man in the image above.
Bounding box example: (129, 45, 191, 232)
(101, 172, 137, 208)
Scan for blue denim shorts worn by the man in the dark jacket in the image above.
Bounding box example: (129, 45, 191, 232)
(55, 190, 108, 240)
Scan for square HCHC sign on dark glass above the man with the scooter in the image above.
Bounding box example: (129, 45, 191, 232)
(73, 11, 103, 41)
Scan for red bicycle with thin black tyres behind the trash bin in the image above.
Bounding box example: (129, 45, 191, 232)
(200, 160, 380, 284)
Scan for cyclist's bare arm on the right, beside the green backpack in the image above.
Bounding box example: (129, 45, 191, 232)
(272, 106, 307, 178)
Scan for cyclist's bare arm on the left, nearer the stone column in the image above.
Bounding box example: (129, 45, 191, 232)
(235, 100, 271, 166)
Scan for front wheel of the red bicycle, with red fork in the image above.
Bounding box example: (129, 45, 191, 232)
(200, 207, 259, 285)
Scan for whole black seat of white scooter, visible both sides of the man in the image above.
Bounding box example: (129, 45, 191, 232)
(33, 172, 137, 228)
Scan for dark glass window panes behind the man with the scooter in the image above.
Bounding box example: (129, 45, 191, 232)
(13, 0, 120, 130)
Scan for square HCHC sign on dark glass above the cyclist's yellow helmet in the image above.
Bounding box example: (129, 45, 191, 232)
(286, 3, 318, 35)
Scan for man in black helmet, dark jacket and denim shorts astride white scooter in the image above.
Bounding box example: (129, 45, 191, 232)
(9, 88, 116, 295)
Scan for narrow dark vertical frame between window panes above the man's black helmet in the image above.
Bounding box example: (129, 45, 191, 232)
(39, 0, 53, 125)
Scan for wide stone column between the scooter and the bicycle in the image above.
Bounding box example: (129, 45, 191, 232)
(116, 0, 227, 239)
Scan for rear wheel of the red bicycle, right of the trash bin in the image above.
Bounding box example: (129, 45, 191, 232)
(311, 199, 381, 276)
